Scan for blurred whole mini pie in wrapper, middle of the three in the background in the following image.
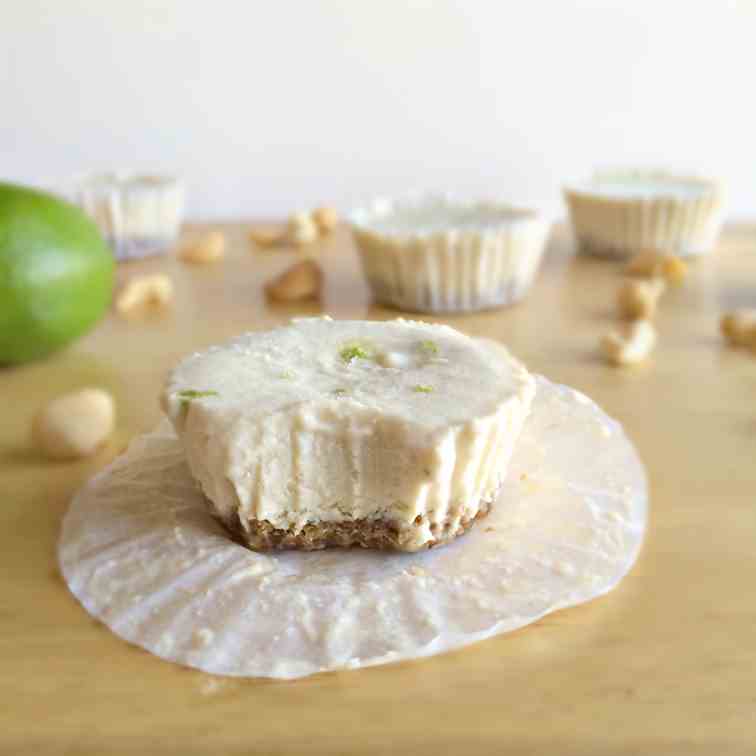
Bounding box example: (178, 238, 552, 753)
(350, 195, 548, 312)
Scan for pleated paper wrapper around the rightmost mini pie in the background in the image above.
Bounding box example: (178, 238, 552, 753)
(565, 189, 724, 259)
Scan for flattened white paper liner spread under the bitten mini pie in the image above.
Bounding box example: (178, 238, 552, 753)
(59, 378, 647, 678)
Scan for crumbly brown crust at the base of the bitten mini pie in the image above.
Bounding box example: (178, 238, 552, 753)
(219, 503, 490, 551)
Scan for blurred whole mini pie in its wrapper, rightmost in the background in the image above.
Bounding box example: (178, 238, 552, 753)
(564, 171, 725, 259)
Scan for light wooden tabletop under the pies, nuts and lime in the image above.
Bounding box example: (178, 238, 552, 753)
(0, 225, 756, 756)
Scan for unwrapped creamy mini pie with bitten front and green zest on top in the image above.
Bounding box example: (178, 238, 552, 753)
(163, 318, 535, 551)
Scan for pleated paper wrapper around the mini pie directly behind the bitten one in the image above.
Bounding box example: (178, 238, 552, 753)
(354, 218, 548, 312)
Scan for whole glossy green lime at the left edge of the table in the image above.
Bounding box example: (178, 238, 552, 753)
(0, 182, 115, 364)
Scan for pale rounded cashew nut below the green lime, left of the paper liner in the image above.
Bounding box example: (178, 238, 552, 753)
(32, 388, 115, 459)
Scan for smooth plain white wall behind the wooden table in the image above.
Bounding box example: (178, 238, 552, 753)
(0, 0, 756, 218)
